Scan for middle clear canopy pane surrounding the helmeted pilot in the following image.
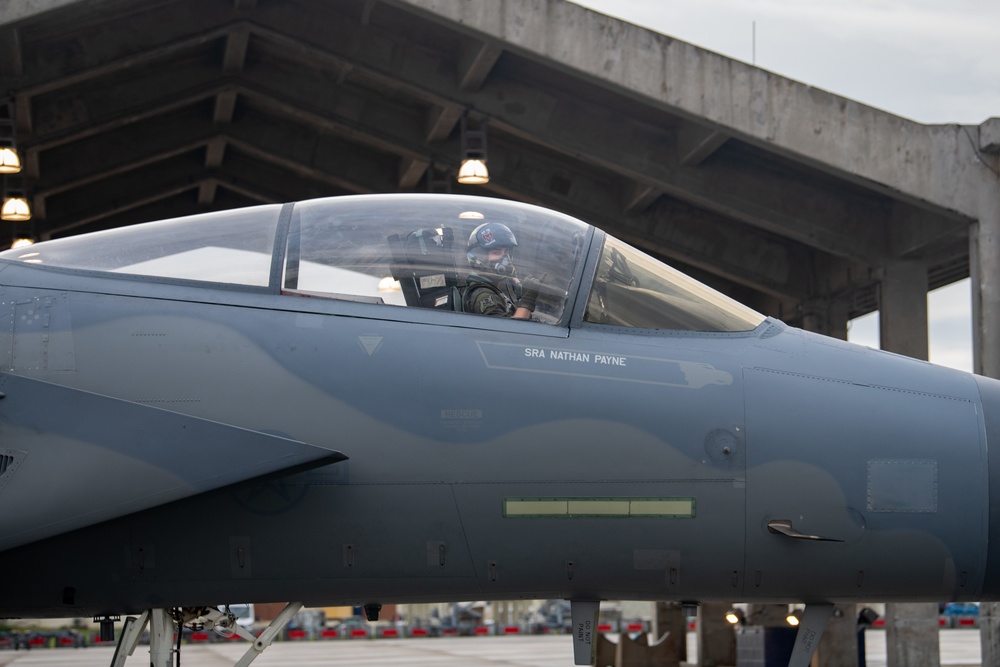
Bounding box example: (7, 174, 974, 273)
(282, 195, 592, 324)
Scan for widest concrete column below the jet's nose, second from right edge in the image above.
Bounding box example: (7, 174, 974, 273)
(885, 602, 940, 667)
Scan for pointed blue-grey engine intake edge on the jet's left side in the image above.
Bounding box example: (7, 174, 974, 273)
(0, 373, 347, 551)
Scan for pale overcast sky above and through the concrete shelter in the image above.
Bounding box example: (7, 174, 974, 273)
(573, 0, 1000, 370)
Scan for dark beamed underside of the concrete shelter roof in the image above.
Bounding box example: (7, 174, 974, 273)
(0, 0, 970, 324)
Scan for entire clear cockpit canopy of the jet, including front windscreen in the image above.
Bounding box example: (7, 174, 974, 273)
(0, 194, 764, 331)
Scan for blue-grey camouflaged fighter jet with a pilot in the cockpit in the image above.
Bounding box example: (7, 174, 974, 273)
(0, 195, 1000, 667)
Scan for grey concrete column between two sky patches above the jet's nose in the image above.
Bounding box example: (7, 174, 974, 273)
(879, 260, 928, 361)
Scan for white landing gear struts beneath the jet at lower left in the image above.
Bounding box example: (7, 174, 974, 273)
(111, 602, 302, 667)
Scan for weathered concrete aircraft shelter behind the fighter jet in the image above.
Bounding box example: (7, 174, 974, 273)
(0, 0, 1000, 357)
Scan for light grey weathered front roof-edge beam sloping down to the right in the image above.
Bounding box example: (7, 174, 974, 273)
(387, 0, 982, 224)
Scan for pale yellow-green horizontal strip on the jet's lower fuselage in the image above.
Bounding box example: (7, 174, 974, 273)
(503, 498, 695, 519)
